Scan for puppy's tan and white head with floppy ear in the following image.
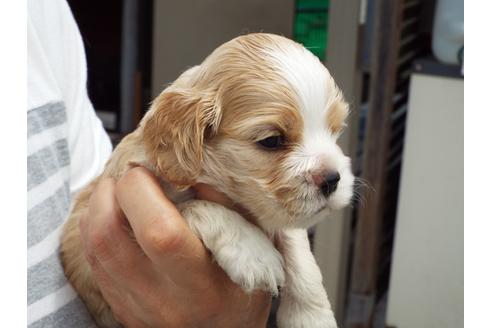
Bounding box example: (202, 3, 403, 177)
(143, 34, 354, 229)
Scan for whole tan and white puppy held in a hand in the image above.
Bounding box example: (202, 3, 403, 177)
(61, 33, 354, 328)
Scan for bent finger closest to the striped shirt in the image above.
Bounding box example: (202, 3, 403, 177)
(80, 178, 150, 281)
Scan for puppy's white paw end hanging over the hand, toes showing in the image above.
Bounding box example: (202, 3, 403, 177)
(214, 233, 285, 295)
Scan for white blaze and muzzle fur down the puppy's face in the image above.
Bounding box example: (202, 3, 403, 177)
(266, 47, 354, 227)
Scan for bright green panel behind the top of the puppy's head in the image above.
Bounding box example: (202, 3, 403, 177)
(294, 0, 330, 61)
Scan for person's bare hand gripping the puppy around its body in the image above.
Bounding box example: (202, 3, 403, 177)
(80, 168, 271, 327)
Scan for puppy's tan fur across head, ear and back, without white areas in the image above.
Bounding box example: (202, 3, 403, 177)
(62, 34, 347, 327)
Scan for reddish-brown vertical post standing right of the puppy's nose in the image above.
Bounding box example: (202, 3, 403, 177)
(346, 0, 403, 328)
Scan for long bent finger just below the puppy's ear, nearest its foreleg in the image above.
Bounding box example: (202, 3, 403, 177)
(116, 167, 210, 276)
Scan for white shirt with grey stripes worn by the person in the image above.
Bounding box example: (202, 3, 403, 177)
(27, 0, 111, 328)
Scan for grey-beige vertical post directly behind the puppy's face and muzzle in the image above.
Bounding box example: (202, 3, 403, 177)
(314, 0, 362, 322)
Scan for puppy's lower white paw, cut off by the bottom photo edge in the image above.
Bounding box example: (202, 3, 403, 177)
(277, 299, 338, 328)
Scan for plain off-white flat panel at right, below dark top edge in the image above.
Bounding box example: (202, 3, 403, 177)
(386, 75, 464, 328)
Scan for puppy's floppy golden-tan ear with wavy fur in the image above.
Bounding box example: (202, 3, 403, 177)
(143, 88, 221, 187)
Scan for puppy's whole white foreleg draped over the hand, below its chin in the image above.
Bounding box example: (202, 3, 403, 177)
(179, 200, 284, 295)
